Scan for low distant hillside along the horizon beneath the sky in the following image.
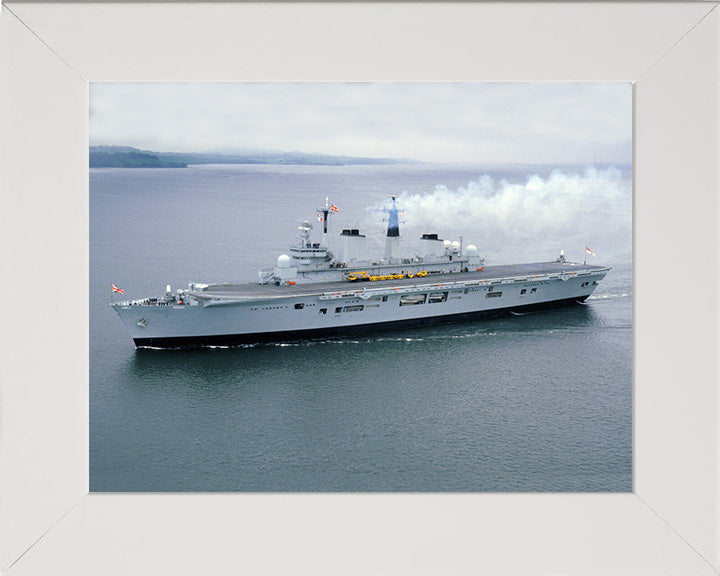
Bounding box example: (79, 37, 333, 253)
(90, 146, 406, 168)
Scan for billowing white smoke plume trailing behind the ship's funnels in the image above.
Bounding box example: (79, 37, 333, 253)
(368, 167, 632, 264)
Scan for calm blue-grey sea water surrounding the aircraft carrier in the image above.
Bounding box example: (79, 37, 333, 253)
(90, 166, 632, 492)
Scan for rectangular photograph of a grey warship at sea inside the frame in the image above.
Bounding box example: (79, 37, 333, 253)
(89, 82, 633, 493)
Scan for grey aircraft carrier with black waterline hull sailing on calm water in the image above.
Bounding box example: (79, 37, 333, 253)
(111, 197, 610, 348)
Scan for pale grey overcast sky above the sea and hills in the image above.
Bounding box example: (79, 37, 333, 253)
(90, 83, 632, 164)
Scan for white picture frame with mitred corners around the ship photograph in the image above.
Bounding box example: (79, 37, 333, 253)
(0, 2, 720, 576)
